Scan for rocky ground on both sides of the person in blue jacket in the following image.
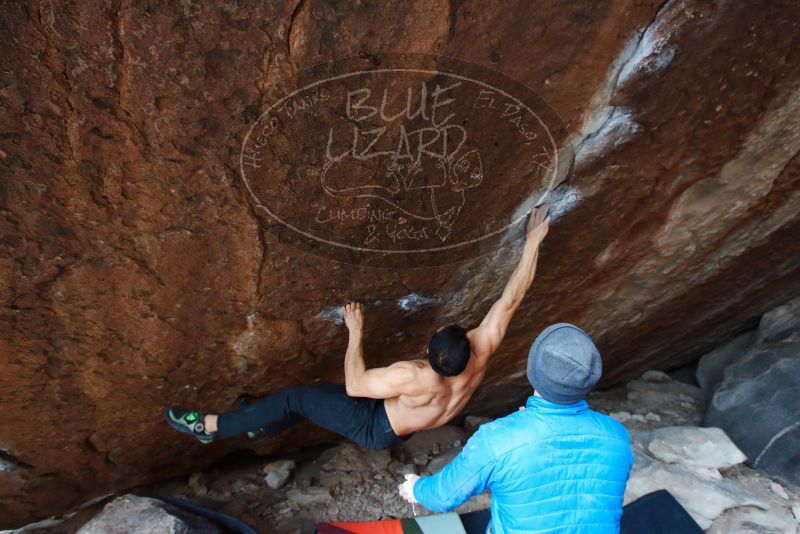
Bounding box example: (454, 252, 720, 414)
(15, 371, 800, 534)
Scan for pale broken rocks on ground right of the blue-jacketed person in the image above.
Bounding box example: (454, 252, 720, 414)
(591, 371, 800, 534)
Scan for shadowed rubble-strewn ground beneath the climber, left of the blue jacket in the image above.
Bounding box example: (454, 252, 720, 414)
(148, 426, 490, 533)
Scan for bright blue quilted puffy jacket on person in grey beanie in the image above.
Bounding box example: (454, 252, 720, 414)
(414, 397, 633, 534)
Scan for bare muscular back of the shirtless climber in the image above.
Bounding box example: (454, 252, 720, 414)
(384, 330, 491, 436)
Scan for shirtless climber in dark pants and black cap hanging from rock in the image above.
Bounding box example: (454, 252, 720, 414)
(164, 206, 550, 449)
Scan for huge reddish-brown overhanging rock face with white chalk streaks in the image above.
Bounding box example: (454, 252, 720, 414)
(0, 0, 800, 528)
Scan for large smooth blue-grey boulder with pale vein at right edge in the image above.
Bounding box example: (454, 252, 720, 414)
(705, 341, 800, 485)
